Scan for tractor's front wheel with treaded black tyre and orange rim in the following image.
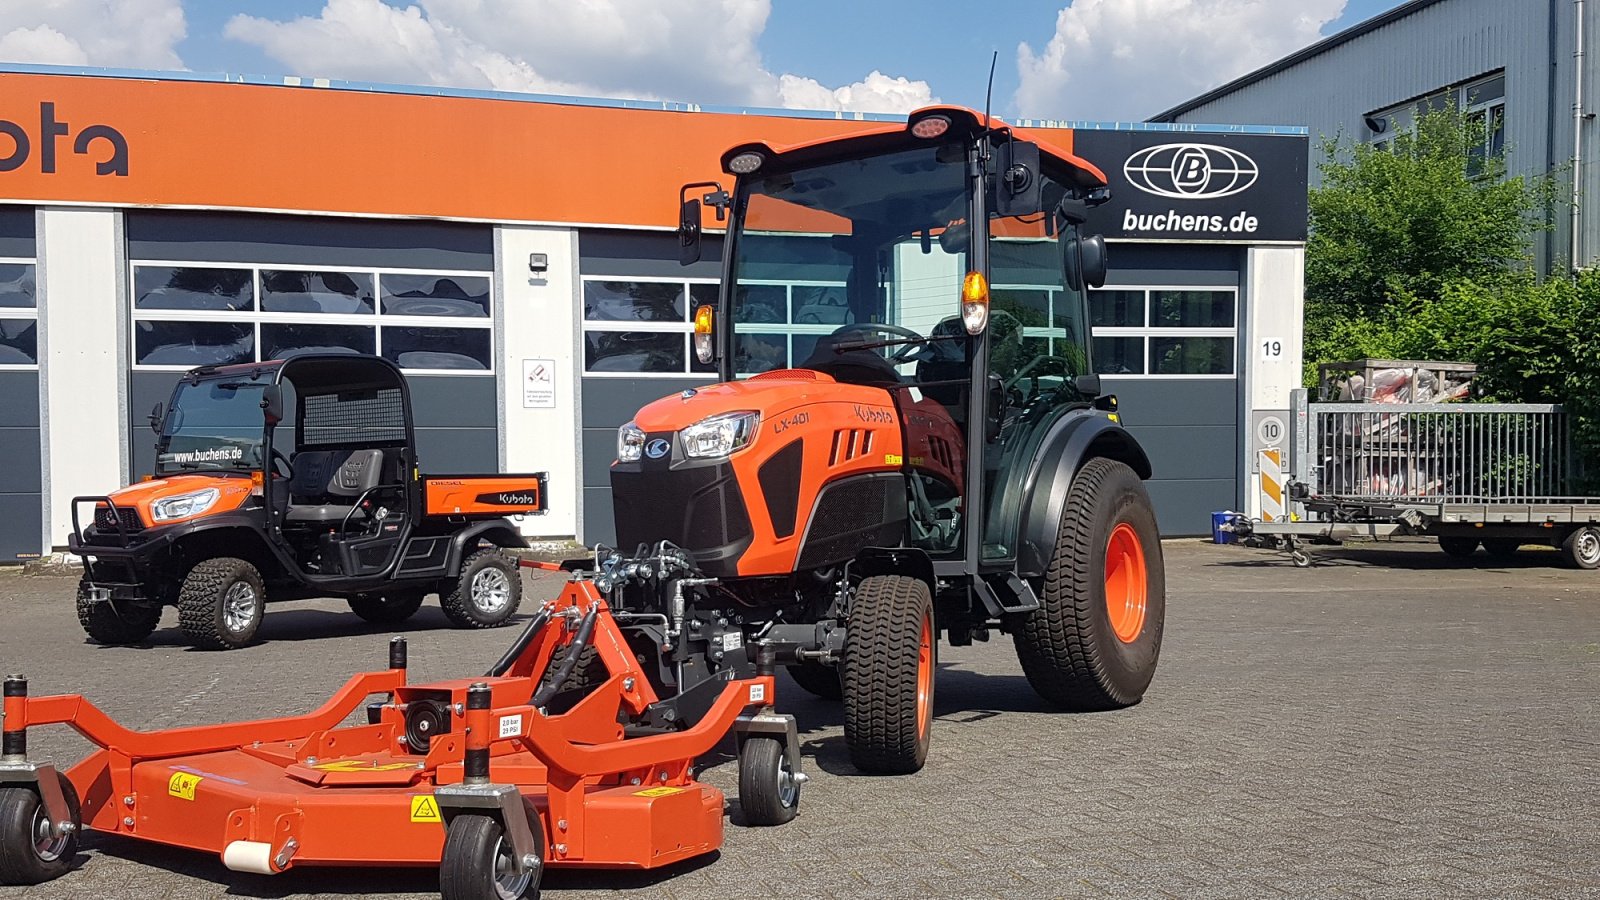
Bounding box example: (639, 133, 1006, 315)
(840, 575, 934, 775)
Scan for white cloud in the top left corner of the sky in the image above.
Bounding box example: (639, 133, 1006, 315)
(0, 0, 186, 69)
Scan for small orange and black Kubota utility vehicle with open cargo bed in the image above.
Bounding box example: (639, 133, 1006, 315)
(67, 354, 544, 650)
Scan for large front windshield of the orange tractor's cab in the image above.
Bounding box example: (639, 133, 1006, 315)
(731, 144, 971, 383)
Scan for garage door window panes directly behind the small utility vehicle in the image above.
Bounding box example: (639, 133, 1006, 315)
(131, 261, 494, 375)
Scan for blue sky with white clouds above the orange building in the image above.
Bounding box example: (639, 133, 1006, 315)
(9, 0, 1400, 120)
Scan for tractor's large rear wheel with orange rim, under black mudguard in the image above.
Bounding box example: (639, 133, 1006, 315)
(1014, 456, 1171, 711)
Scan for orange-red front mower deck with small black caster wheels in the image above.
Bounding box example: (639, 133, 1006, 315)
(0, 566, 805, 900)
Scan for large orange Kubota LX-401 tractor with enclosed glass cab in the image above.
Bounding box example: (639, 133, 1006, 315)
(602, 107, 1165, 773)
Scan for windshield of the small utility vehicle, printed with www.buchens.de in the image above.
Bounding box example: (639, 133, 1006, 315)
(155, 373, 272, 474)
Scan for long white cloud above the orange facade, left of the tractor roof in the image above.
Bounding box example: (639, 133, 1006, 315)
(224, 0, 933, 112)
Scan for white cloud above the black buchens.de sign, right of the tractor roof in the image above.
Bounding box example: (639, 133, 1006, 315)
(1013, 0, 1346, 122)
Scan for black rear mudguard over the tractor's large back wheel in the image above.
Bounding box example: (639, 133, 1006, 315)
(1016, 415, 1150, 578)
